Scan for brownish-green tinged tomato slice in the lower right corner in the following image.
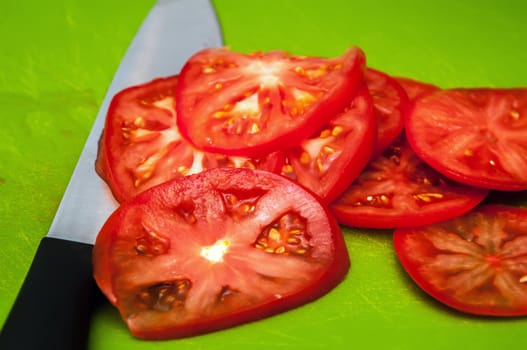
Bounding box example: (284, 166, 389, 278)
(393, 205, 527, 316)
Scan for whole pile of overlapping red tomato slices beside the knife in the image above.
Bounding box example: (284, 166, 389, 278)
(94, 47, 527, 338)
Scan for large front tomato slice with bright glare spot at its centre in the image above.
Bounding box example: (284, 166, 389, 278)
(94, 168, 349, 339)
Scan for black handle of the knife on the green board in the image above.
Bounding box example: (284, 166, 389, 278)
(0, 237, 100, 350)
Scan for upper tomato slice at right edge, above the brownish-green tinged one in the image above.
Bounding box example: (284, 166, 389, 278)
(406, 88, 527, 191)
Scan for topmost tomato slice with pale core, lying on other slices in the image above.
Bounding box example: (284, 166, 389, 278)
(176, 47, 365, 156)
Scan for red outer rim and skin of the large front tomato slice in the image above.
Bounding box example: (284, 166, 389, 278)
(93, 168, 350, 340)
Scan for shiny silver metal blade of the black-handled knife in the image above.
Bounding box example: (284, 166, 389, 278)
(48, 0, 222, 244)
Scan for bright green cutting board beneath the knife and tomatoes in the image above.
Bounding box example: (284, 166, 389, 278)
(0, 0, 527, 350)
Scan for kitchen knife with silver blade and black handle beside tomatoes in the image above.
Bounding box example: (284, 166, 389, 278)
(0, 0, 222, 350)
